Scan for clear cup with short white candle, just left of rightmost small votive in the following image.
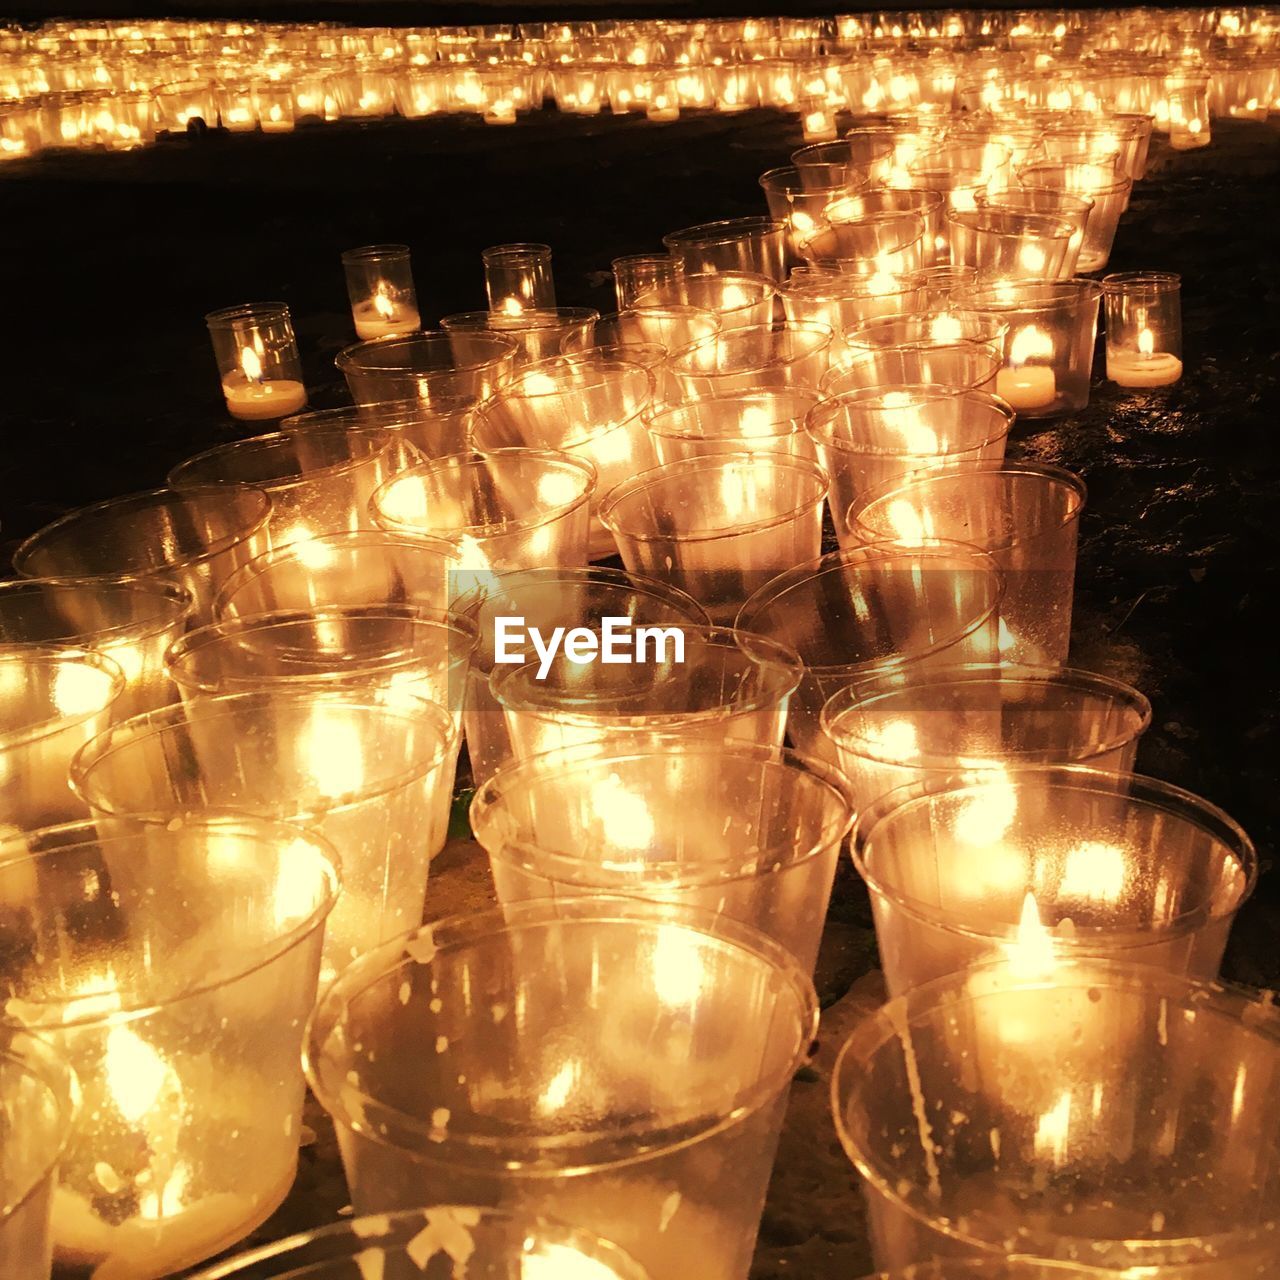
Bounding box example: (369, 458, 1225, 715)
(952, 279, 1102, 419)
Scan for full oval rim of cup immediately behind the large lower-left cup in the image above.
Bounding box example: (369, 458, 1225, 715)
(68, 687, 457, 826)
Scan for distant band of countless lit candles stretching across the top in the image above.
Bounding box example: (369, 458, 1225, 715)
(0, 9, 1280, 160)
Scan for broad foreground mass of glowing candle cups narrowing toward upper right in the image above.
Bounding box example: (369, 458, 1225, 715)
(0, 15, 1280, 1280)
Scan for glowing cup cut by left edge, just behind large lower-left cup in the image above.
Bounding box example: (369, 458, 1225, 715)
(0, 645, 124, 831)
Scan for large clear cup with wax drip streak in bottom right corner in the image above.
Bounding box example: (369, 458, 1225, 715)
(832, 961, 1280, 1280)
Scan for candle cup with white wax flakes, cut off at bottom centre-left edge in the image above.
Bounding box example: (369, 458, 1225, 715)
(183, 1204, 650, 1280)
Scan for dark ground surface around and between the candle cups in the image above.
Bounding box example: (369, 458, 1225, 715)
(0, 111, 1280, 1280)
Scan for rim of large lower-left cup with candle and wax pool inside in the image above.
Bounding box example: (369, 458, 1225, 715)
(0, 809, 342, 1034)
